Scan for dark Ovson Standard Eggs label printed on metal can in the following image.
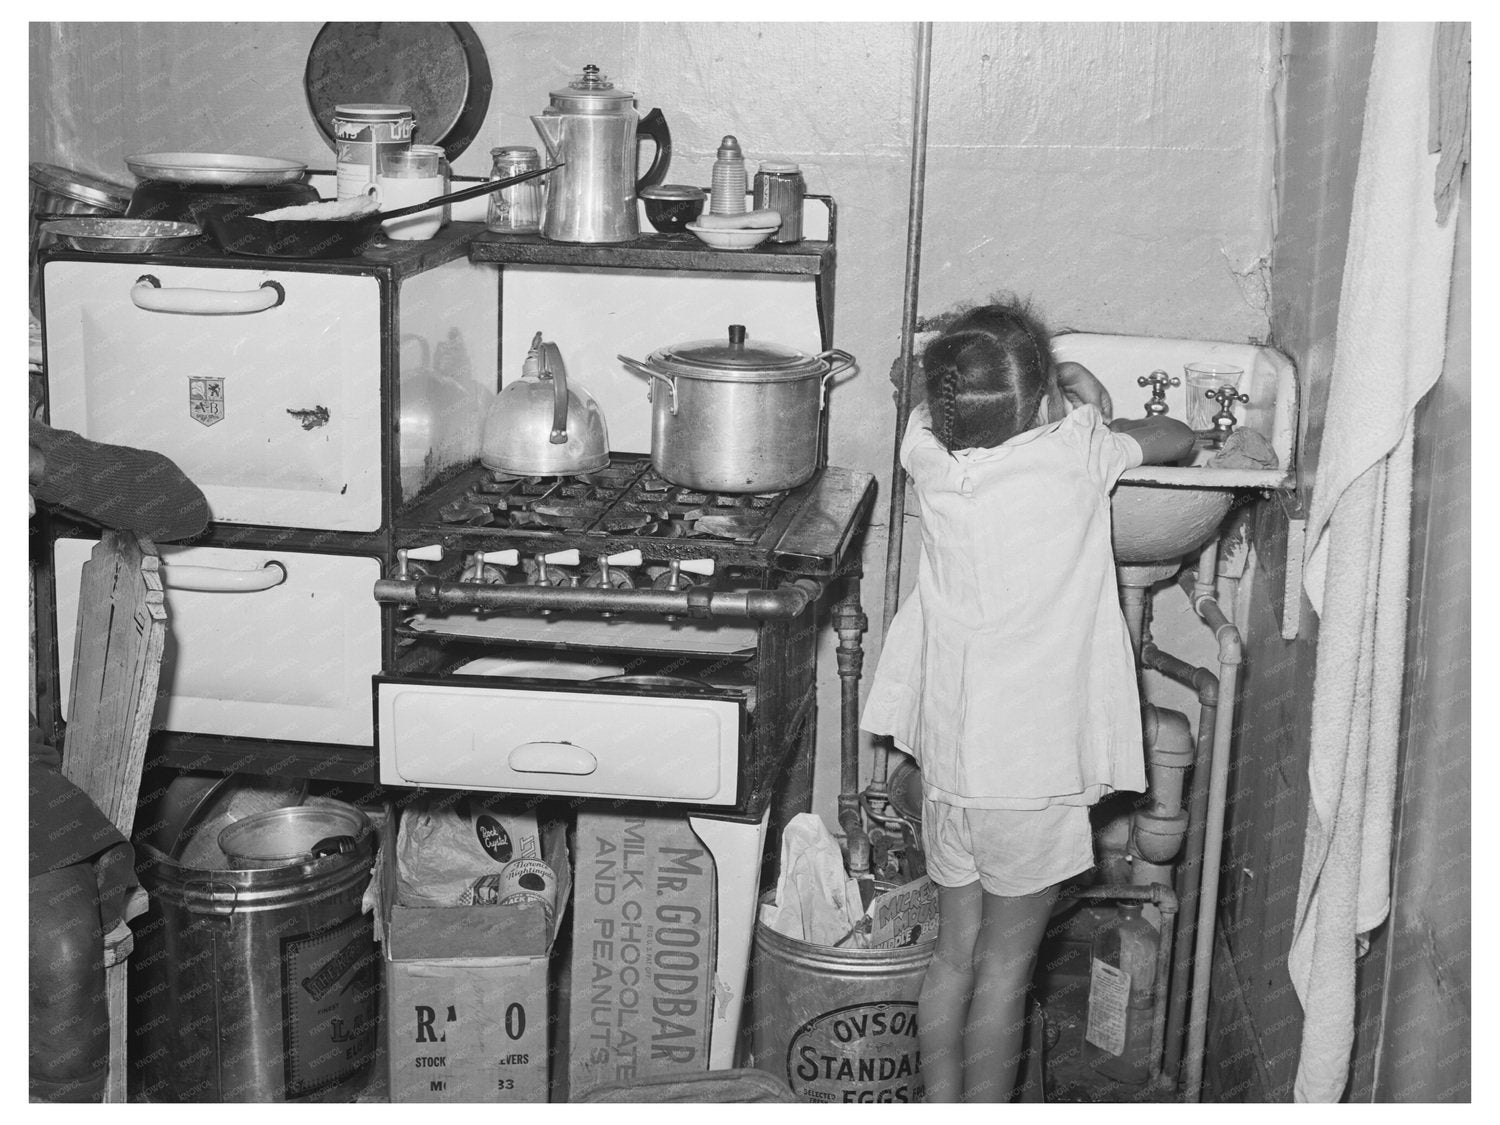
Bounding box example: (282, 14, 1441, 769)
(786, 1001, 926, 1103)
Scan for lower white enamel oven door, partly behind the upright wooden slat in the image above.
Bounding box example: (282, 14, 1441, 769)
(54, 539, 381, 746)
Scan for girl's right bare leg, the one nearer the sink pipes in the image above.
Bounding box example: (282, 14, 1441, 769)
(960, 887, 1058, 1103)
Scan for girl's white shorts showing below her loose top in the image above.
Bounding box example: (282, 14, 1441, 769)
(923, 800, 1094, 899)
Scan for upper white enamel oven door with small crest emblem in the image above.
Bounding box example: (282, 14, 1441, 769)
(44, 261, 381, 531)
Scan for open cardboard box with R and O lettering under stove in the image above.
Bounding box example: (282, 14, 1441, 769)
(375, 824, 572, 1103)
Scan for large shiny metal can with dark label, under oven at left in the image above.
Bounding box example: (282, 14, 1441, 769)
(138, 809, 380, 1103)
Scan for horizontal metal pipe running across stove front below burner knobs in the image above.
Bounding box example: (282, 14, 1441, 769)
(375, 578, 824, 621)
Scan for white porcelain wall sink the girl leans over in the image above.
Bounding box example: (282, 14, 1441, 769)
(1053, 333, 1298, 566)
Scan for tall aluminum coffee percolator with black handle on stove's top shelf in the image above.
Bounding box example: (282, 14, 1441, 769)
(531, 65, 672, 243)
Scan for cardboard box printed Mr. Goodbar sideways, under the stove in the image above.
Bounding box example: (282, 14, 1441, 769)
(569, 810, 716, 1101)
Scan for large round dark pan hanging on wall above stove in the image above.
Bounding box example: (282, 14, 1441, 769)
(303, 23, 495, 161)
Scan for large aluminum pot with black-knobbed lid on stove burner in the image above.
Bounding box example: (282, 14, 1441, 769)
(618, 324, 855, 492)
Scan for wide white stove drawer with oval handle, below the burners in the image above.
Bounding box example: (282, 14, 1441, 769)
(375, 678, 744, 806)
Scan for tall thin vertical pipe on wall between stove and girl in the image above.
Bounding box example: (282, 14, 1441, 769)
(872, 23, 933, 794)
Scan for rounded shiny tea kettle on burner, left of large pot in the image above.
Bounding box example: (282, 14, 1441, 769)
(479, 332, 609, 477)
